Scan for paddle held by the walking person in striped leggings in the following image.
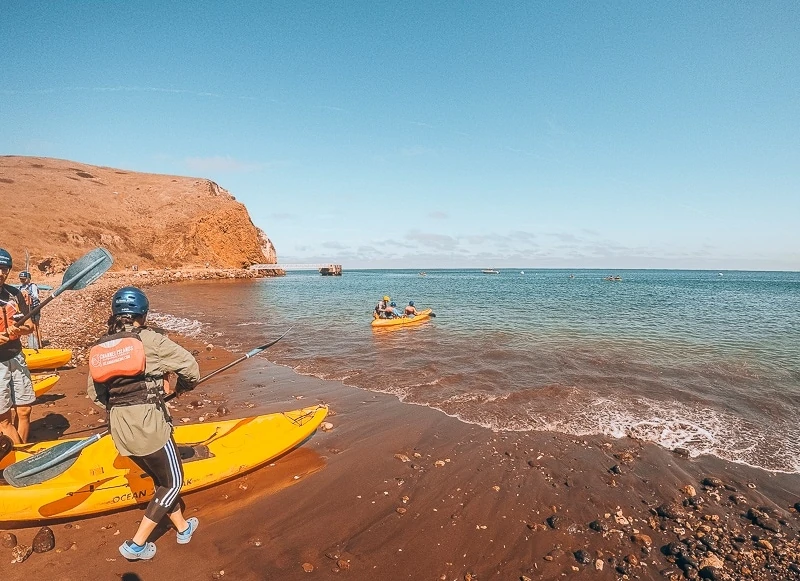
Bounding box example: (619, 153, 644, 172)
(3, 327, 293, 488)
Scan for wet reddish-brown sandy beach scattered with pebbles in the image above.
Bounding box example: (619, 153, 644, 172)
(0, 276, 800, 581)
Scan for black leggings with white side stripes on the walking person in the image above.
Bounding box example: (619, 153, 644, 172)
(131, 437, 183, 522)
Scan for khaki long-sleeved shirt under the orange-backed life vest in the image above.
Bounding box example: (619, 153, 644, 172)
(87, 328, 200, 456)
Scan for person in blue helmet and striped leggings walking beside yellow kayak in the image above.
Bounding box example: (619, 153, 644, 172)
(88, 287, 200, 560)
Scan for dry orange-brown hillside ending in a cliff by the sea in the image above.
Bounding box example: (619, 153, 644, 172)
(0, 156, 277, 272)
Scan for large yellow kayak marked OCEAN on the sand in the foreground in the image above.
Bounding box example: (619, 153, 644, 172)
(0, 405, 328, 522)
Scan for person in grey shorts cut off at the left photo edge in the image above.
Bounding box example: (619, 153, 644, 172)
(0, 248, 36, 444)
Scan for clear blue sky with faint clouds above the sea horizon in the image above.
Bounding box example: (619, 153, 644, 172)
(0, 0, 800, 270)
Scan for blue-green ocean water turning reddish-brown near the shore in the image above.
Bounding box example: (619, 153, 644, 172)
(149, 269, 800, 472)
